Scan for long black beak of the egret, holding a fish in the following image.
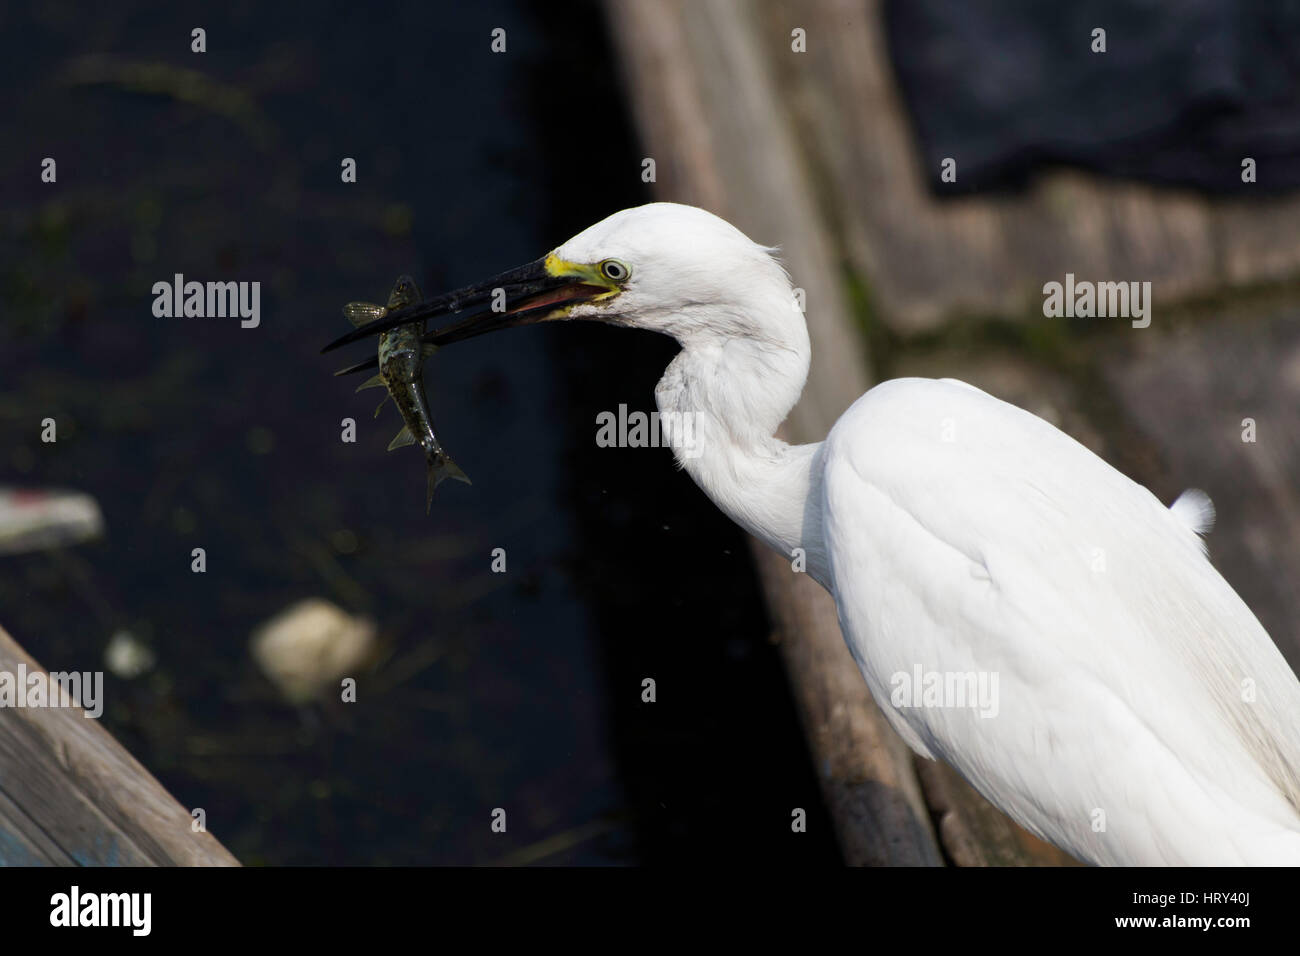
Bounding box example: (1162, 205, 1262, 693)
(321, 258, 608, 375)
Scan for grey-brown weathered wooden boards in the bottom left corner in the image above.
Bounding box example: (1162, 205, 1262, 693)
(0, 628, 238, 866)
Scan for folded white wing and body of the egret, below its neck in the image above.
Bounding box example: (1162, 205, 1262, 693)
(823, 380, 1300, 862)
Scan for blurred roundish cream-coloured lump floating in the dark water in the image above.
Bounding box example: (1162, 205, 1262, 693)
(252, 597, 376, 704)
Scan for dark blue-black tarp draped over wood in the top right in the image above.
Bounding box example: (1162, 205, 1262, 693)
(885, 0, 1300, 193)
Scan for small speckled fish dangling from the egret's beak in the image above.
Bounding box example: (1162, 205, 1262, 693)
(343, 276, 469, 514)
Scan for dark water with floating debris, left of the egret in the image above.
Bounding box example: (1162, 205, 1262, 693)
(0, 3, 837, 864)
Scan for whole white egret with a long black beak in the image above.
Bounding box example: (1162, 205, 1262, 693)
(322, 203, 1300, 864)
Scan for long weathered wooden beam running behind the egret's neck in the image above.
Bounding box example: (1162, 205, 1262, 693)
(608, 0, 941, 865)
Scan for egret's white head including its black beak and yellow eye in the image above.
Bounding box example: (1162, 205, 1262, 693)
(326, 203, 807, 368)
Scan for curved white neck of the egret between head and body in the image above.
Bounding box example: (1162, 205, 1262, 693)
(655, 299, 829, 587)
